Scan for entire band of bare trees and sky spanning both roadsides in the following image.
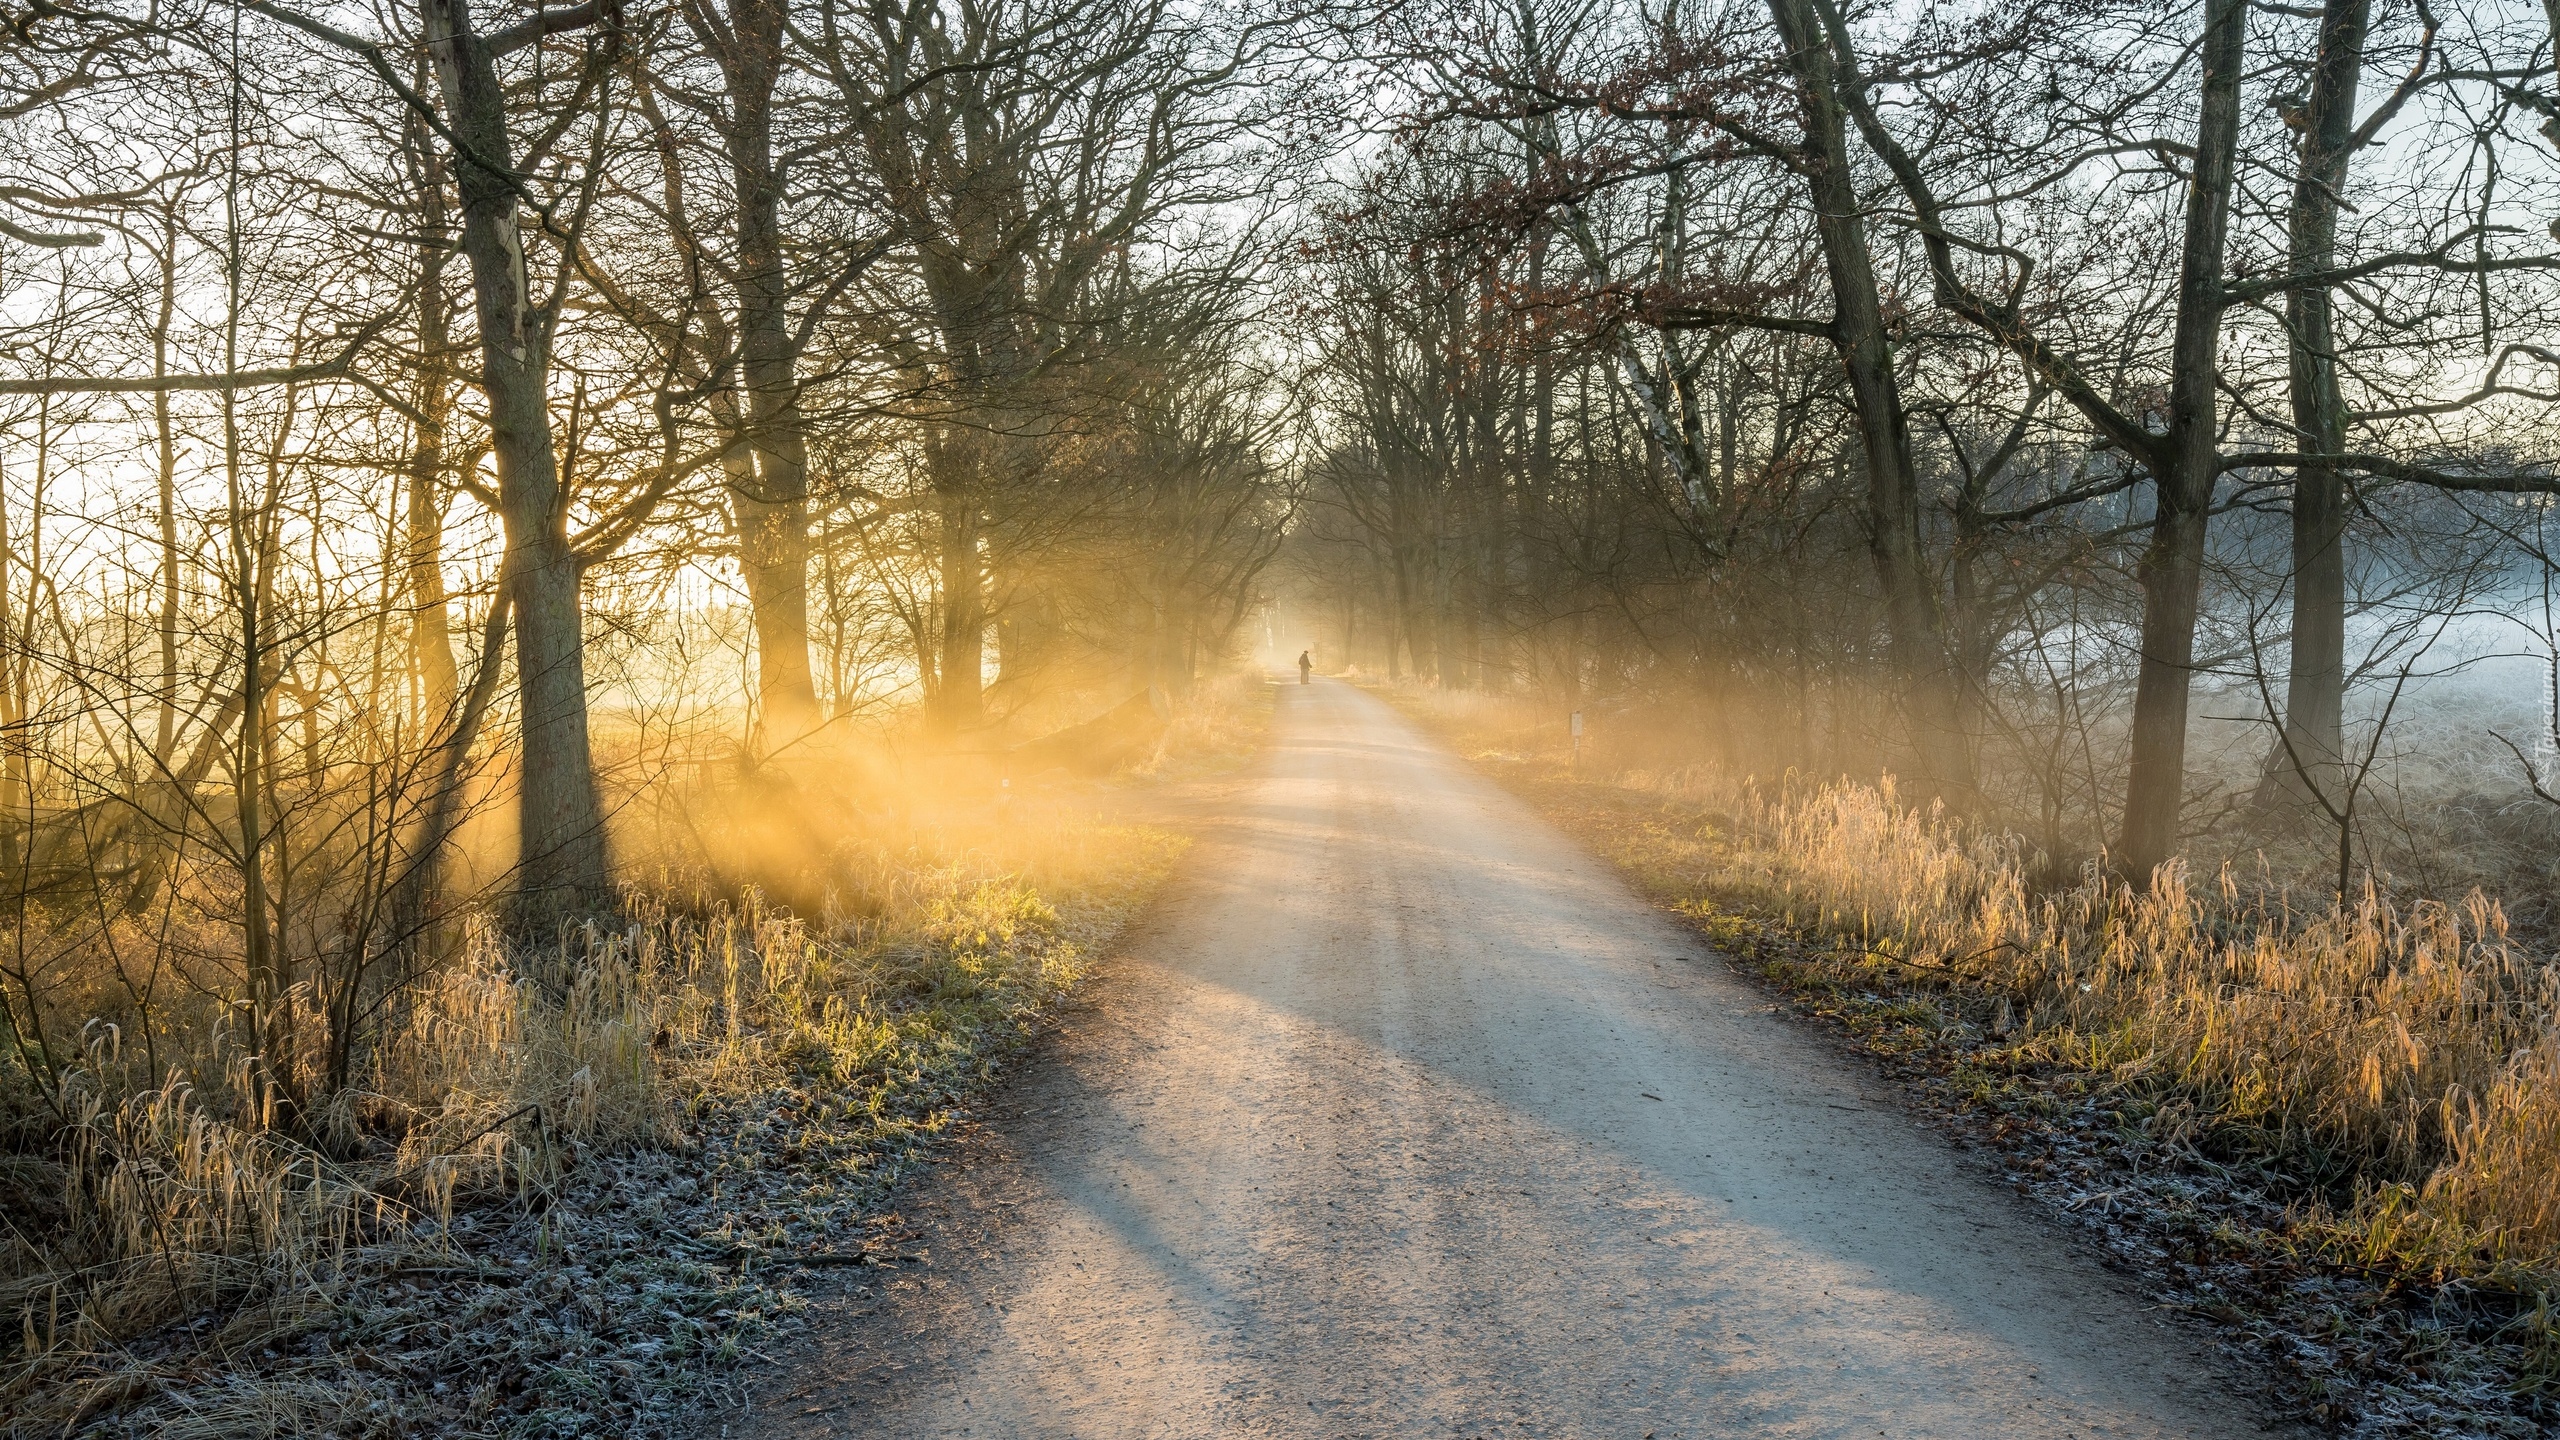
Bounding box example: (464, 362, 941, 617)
(0, 0, 2560, 1132)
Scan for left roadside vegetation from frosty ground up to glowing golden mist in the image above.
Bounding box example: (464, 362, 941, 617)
(0, 682, 1265, 1435)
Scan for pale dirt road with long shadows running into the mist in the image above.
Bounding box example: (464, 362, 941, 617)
(747, 684, 2258, 1440)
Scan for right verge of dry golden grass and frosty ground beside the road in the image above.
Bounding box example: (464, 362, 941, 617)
(1400, 692, 2560, 1435)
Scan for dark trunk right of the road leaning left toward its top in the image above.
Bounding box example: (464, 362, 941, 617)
(1769, 0, 1974, 807)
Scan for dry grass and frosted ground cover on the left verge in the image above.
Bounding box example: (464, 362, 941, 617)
(0, 828, 1178, 1435)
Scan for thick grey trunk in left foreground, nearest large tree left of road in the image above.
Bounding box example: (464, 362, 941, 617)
(422, 0, 612, 907)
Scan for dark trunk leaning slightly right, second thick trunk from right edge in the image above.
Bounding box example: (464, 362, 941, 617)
(2115, 0, 2248, 881)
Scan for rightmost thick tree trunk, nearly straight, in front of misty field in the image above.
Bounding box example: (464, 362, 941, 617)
(2258, 0, 2373, 802)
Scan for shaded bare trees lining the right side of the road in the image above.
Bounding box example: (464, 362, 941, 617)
(1295, 0, 2560, 889)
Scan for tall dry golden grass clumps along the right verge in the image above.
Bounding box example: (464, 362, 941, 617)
(1710, 776, 2560, 1199)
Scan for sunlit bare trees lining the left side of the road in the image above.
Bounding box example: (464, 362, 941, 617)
(0, 0, 1334, 1107)
